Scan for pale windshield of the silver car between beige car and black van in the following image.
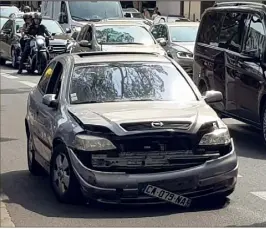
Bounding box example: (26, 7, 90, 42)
(169, 26, 198, 42)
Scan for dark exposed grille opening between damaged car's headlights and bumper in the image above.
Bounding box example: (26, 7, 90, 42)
(88, 132, 219, 174)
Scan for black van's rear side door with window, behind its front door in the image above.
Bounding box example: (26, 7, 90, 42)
(218, 11, 248, 115)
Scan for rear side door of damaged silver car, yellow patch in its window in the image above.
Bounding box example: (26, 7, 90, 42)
(29, 61, 57, 160)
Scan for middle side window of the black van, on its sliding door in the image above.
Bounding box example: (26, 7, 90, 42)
(219, 12, 248, 52)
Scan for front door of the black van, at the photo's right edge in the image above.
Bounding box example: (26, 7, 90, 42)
(236, 14, 266, 123)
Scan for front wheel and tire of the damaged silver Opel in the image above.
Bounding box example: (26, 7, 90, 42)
(50, 144, 84, 204)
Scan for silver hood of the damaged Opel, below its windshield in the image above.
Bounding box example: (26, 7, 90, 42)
(68, 101, 218, 135)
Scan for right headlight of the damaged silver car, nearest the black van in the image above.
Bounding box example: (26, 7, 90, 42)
(199, 121, 231, 146)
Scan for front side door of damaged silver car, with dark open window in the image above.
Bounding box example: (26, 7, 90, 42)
(37, 59, 66, 161)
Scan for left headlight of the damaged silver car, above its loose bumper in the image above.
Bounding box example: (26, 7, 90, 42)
(74, 134, 116, 151)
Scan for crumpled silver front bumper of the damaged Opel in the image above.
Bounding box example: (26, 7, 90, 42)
(69, 142, 238, 204)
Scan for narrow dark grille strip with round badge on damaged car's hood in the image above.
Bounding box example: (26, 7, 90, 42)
(120, 121, 191, 131)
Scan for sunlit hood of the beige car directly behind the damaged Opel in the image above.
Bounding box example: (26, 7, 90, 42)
(102, 44, 165, 55)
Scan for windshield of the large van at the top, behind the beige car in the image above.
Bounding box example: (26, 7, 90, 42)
(69, 1, 123, 21)
